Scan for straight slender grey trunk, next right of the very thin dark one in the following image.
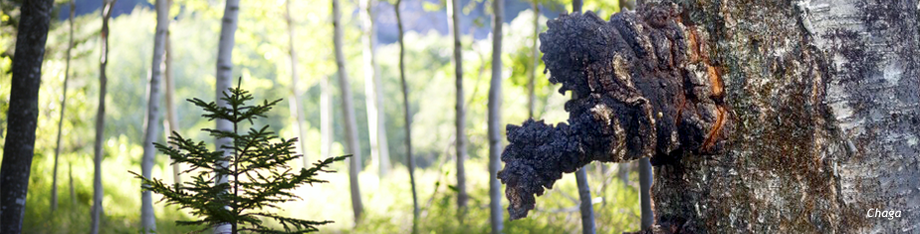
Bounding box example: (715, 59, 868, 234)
(447, 0, 469, 214)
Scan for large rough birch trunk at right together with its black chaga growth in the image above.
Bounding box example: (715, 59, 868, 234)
(500, 0, 920, 233)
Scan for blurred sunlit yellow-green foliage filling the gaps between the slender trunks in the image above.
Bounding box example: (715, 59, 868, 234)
(0, 0, 640, 233)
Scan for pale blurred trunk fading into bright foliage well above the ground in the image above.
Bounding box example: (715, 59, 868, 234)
(359, 0, 390, 178)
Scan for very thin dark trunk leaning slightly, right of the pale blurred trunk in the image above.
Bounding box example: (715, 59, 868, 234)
(394, 0, 419, 233)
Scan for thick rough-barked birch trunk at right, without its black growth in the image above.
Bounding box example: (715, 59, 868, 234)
(653, 0, 920, 230)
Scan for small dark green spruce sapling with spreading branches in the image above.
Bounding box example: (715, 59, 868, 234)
(131, 83, 348, 233)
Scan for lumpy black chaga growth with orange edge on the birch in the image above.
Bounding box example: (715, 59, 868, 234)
(498, 3, 731, 220)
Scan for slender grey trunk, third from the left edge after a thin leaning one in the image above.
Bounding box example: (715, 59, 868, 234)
(90, 0, 117, 234)
